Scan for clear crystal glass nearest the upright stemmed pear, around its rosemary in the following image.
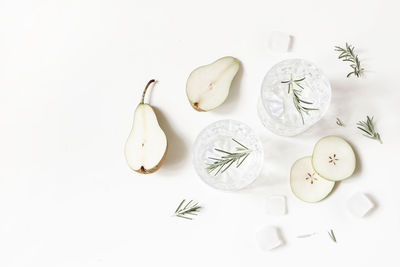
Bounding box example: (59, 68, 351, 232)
(193, 120, 264, 190)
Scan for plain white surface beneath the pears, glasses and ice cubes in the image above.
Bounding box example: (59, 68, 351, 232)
(0, 0, 400, 267)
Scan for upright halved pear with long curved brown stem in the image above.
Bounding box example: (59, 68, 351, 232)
(125, 80, 168, 174)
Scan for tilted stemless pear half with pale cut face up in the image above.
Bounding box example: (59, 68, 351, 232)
(186, 57, 240, 111)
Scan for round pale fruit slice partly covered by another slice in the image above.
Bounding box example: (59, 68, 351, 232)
(290, 157, 335, 202)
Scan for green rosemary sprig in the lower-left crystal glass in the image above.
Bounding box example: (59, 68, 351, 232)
(206, 138, 252, 176)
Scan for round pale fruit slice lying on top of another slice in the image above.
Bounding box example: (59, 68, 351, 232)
(312, 136, 356, 181)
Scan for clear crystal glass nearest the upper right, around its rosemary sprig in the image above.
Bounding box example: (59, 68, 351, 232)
(257, 59, 331, 136)
